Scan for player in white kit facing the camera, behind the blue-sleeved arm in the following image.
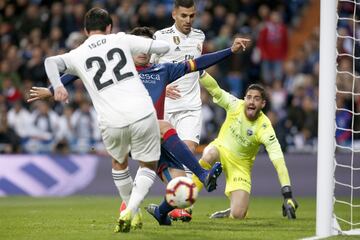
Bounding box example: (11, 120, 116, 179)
(151, 0, 205, 219)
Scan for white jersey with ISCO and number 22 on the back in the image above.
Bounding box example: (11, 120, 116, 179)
(60, 33, 155, 128)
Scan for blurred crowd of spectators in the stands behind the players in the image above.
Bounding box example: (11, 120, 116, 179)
(0, 0, 352, 153)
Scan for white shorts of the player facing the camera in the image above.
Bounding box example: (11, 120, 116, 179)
(165, 110, 202, 144)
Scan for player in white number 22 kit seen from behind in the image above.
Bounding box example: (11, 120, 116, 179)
(45, 8, 169, 232)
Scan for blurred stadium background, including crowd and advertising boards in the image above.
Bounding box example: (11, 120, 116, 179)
(0, 0, 353, 196)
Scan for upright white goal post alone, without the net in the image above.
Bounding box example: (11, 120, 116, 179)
(316, 0, 337, 237)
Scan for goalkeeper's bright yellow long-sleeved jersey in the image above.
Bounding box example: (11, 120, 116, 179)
(200, 74, 290, 186)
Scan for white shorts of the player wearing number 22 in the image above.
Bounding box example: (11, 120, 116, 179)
(101, 113, 160, 163)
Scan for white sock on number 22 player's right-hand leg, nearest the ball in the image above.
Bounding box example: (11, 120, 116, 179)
(126, 167, 156, 213)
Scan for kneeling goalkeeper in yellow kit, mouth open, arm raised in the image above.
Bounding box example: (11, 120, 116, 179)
(193, 74, 298, 219)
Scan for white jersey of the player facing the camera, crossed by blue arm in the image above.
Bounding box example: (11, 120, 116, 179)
(151, 25, 205, 113)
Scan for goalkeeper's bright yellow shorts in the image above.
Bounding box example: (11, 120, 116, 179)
(209, 142, 251, 197)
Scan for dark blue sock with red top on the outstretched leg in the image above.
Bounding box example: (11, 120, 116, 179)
(162, 128, 208, 182)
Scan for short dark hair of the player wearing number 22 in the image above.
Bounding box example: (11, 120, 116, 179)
(84, 7, 112, 32)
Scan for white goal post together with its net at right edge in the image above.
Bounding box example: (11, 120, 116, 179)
(316, 0, 360, 238)
